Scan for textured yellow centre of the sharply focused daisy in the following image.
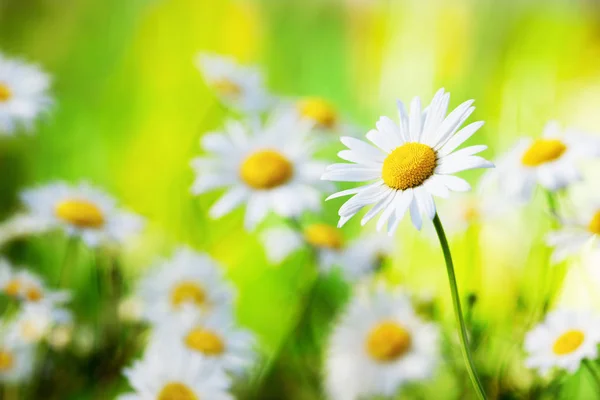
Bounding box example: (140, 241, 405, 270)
(382, 143, 437, 190)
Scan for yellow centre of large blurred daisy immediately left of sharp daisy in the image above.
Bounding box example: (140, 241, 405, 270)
(240, 150, 294, 190)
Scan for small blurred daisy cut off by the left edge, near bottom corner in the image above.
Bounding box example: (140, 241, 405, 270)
(0, 332, 35, 383)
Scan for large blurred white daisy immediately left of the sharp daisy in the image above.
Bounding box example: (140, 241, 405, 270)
(192, 112, 324, 229)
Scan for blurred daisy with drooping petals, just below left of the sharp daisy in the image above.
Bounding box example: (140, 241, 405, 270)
(261, 223, 393, 281)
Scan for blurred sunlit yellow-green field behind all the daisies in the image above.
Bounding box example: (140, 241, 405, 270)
(0, 0, 600, 400)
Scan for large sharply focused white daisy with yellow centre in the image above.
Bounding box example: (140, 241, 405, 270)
(322, 89, 493, 235)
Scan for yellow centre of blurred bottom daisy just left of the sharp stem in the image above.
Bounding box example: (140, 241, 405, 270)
(366, 321, 412, 362)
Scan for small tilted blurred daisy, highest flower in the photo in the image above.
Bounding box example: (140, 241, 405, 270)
(196, 53, 273, 113)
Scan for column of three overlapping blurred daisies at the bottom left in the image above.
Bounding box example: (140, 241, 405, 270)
(120, 248, 256, 400)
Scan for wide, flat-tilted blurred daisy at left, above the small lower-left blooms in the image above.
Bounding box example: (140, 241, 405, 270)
(21, 182, 144, 247)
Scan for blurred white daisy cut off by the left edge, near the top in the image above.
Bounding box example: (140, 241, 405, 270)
(0, 53, 52, 135)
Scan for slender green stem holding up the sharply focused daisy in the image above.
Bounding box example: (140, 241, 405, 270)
(433, 214, 486, 400)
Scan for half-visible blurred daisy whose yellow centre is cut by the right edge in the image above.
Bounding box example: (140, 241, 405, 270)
(546, 201, 600, 262)
